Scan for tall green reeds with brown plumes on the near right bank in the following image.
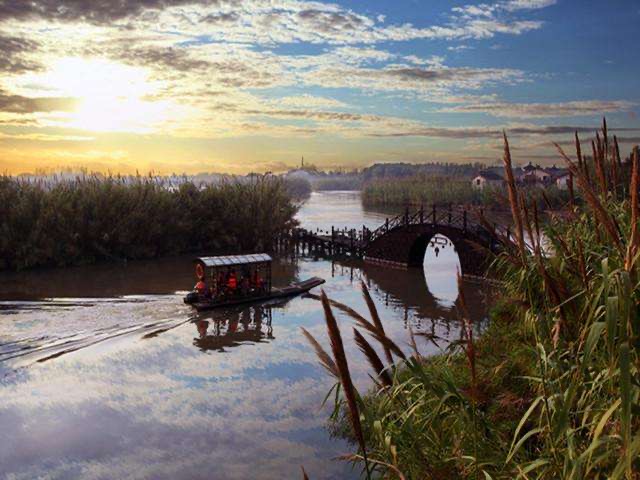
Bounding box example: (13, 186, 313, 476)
(304, 125, 640, 480)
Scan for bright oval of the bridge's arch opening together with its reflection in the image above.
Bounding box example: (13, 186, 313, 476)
(416, 234, 461, 307)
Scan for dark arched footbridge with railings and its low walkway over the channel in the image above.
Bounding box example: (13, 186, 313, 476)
(295, 206, 509, 276)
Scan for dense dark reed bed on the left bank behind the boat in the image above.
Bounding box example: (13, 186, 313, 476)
(0, 176, 296, 270)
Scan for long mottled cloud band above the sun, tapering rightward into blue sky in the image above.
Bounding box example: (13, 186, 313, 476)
(91, 40, 525, 105)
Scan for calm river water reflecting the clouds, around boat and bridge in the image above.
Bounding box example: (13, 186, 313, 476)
(0, 193, 496, 479)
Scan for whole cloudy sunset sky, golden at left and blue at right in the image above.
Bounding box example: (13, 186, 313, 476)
(0, 0, 640, 174)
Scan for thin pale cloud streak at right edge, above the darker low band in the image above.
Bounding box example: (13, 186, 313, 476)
(441, 100, 636, 118)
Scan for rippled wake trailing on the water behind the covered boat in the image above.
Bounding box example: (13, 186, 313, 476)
(0, 292, 192, 376)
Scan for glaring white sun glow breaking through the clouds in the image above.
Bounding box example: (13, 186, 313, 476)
(32, 57, 171, 133)
